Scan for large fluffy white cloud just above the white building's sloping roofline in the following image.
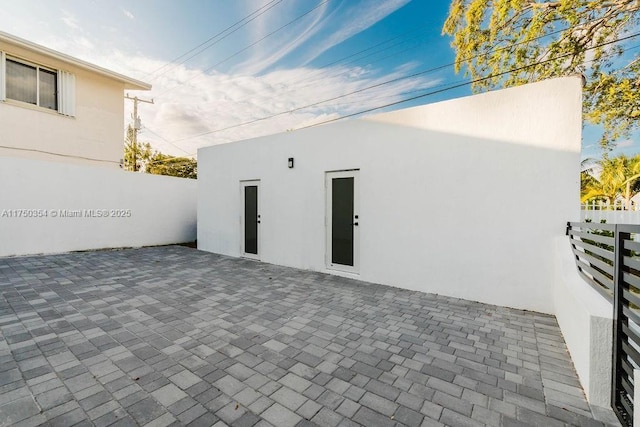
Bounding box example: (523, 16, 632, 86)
(109, 54, 438, 155)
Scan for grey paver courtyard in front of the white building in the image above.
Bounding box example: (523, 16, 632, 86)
(0, 246, 611, 427)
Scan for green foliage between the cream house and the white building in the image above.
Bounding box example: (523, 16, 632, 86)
(124, 126, 198, 179)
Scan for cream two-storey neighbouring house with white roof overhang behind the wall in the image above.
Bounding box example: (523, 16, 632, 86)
(0, 32, 151, 168)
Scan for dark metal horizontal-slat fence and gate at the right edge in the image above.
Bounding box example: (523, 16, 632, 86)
(567, 222, 640, 426)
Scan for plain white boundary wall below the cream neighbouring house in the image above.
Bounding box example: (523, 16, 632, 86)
(0, 157, 197, 256)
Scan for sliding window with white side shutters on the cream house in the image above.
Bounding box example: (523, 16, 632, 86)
(0, 52, 75, 116)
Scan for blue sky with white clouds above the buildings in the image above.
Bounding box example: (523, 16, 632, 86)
(0, 0, 637, 160)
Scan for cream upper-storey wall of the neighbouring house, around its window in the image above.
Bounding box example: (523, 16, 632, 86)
(0, 41, 134, 169)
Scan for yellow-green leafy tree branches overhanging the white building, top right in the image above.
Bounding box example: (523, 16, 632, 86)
(443, 0, 640, 150)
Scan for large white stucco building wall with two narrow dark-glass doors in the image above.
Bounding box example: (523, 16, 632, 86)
(198, 77, 581, 313)
